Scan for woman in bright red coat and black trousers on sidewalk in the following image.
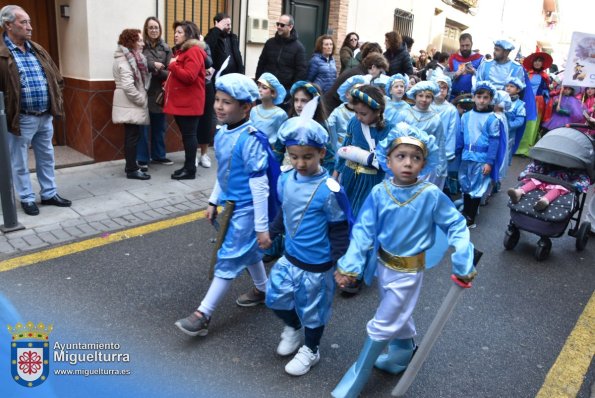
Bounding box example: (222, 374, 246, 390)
(163, 21, 207, 180)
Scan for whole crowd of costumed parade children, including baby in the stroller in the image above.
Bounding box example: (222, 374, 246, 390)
(170, 32, 595, 397)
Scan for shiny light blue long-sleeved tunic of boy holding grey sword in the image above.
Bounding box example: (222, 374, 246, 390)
(337, 180, 474, 284)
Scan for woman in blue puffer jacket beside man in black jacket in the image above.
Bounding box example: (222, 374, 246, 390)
(307, 35, 337, 93)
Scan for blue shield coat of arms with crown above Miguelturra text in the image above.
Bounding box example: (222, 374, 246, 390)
(8, 322, 54, 387)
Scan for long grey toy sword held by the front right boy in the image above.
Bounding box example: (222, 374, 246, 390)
(392, 249, 483, 397)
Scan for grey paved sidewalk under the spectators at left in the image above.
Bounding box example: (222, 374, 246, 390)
(0, 148, 217, 260)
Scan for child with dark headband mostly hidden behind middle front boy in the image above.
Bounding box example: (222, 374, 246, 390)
(273, 80, 335, 173)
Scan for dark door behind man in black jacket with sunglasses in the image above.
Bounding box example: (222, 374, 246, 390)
(283, 0, 328, 60)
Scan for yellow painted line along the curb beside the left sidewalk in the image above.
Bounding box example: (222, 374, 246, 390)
(0, 211, 205, 272)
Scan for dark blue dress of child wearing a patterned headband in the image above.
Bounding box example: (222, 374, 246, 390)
(336, 117, 392, 217)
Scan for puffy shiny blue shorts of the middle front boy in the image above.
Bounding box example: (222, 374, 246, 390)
(265, 256, 335, 329)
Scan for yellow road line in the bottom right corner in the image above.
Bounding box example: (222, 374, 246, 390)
(536, 293, 595, 398)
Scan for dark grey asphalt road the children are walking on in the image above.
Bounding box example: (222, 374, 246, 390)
(0, 158, 595, 398)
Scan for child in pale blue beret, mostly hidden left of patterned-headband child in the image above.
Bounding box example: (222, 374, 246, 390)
(327, 75, 367, 153)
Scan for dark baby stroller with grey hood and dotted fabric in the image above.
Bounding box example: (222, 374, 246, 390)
(504, 127, 595, 261)
